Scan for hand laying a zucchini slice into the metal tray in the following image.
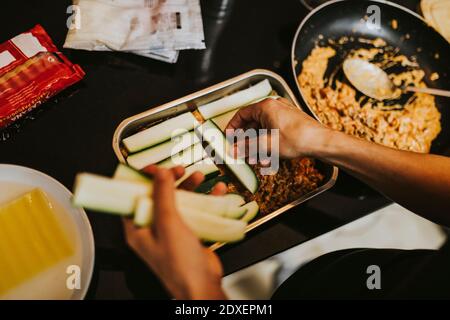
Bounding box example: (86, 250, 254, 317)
(227, 98, 331, 159)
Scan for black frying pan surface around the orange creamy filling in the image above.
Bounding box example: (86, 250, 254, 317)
(292, 0, 450, 156)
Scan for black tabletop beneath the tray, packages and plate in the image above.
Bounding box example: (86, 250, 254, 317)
(0, 0, 417, 299)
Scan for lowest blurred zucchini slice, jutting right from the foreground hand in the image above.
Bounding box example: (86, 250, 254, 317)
(181, 207, 247, 242)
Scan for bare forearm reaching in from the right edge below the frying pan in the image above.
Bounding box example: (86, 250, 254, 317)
(311, 129, 450, 226)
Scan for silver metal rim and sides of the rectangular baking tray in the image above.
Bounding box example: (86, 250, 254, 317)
(113, 69, 338, 249)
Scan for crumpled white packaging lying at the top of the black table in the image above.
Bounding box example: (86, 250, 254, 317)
(64, 0, 205, 62)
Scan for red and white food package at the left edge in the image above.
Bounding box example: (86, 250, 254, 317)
(0, 25, 85, 129)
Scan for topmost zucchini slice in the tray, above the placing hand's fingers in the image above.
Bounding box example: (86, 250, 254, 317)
(198, 79, 272, 120)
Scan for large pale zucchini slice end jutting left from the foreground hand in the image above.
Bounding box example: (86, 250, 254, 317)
(73, 173, 152, 215)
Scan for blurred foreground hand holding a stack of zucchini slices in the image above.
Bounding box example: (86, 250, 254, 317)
(123, 166, 226, 300)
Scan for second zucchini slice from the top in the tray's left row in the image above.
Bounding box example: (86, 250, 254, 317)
(127, 131, 200, 170)
